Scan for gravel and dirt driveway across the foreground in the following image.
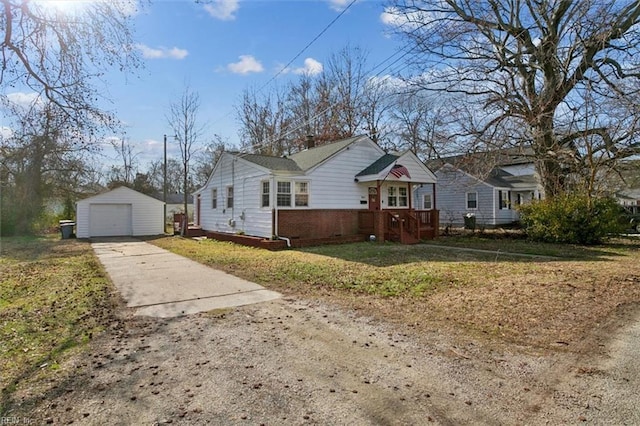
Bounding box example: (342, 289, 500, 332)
(25, 297, 640, 425)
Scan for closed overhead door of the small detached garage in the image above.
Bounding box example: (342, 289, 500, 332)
(89, 204, 133, 237)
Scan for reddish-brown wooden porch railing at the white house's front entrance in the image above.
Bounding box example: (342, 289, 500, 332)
(358, 210, 440, 244)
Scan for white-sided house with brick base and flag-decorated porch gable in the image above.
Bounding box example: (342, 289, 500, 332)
(194, 136, 438, 246)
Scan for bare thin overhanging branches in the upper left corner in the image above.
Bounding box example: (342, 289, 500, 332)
(0, 0, 140, 123)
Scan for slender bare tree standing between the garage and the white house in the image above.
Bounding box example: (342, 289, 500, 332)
(166, 86, 204, 235)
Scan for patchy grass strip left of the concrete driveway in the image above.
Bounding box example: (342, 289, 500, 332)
(0, 236, 117, 414)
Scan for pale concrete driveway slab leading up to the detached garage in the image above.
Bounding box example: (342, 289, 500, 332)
(91, 238, 280, 318)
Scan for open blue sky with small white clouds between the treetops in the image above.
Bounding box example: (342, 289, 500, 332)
(97, 0, 400, 170)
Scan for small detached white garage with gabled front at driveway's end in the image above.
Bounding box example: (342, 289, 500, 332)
(76, 186, 164, 238)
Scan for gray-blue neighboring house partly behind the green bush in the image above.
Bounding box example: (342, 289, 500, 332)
(416, 148, 543, 227)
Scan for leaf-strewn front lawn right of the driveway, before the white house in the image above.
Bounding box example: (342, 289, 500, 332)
(153, 236, 640, 349)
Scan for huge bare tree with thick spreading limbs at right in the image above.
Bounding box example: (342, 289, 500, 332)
(387, 0, 640, 197)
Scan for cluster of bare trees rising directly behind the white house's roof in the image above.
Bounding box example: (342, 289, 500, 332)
(238, 46, 388, 151)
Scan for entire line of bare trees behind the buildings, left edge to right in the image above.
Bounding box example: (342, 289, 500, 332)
(0, 0, 640, 240)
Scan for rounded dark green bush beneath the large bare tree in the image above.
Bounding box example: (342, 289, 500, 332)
(519, 195, 624, 244)
